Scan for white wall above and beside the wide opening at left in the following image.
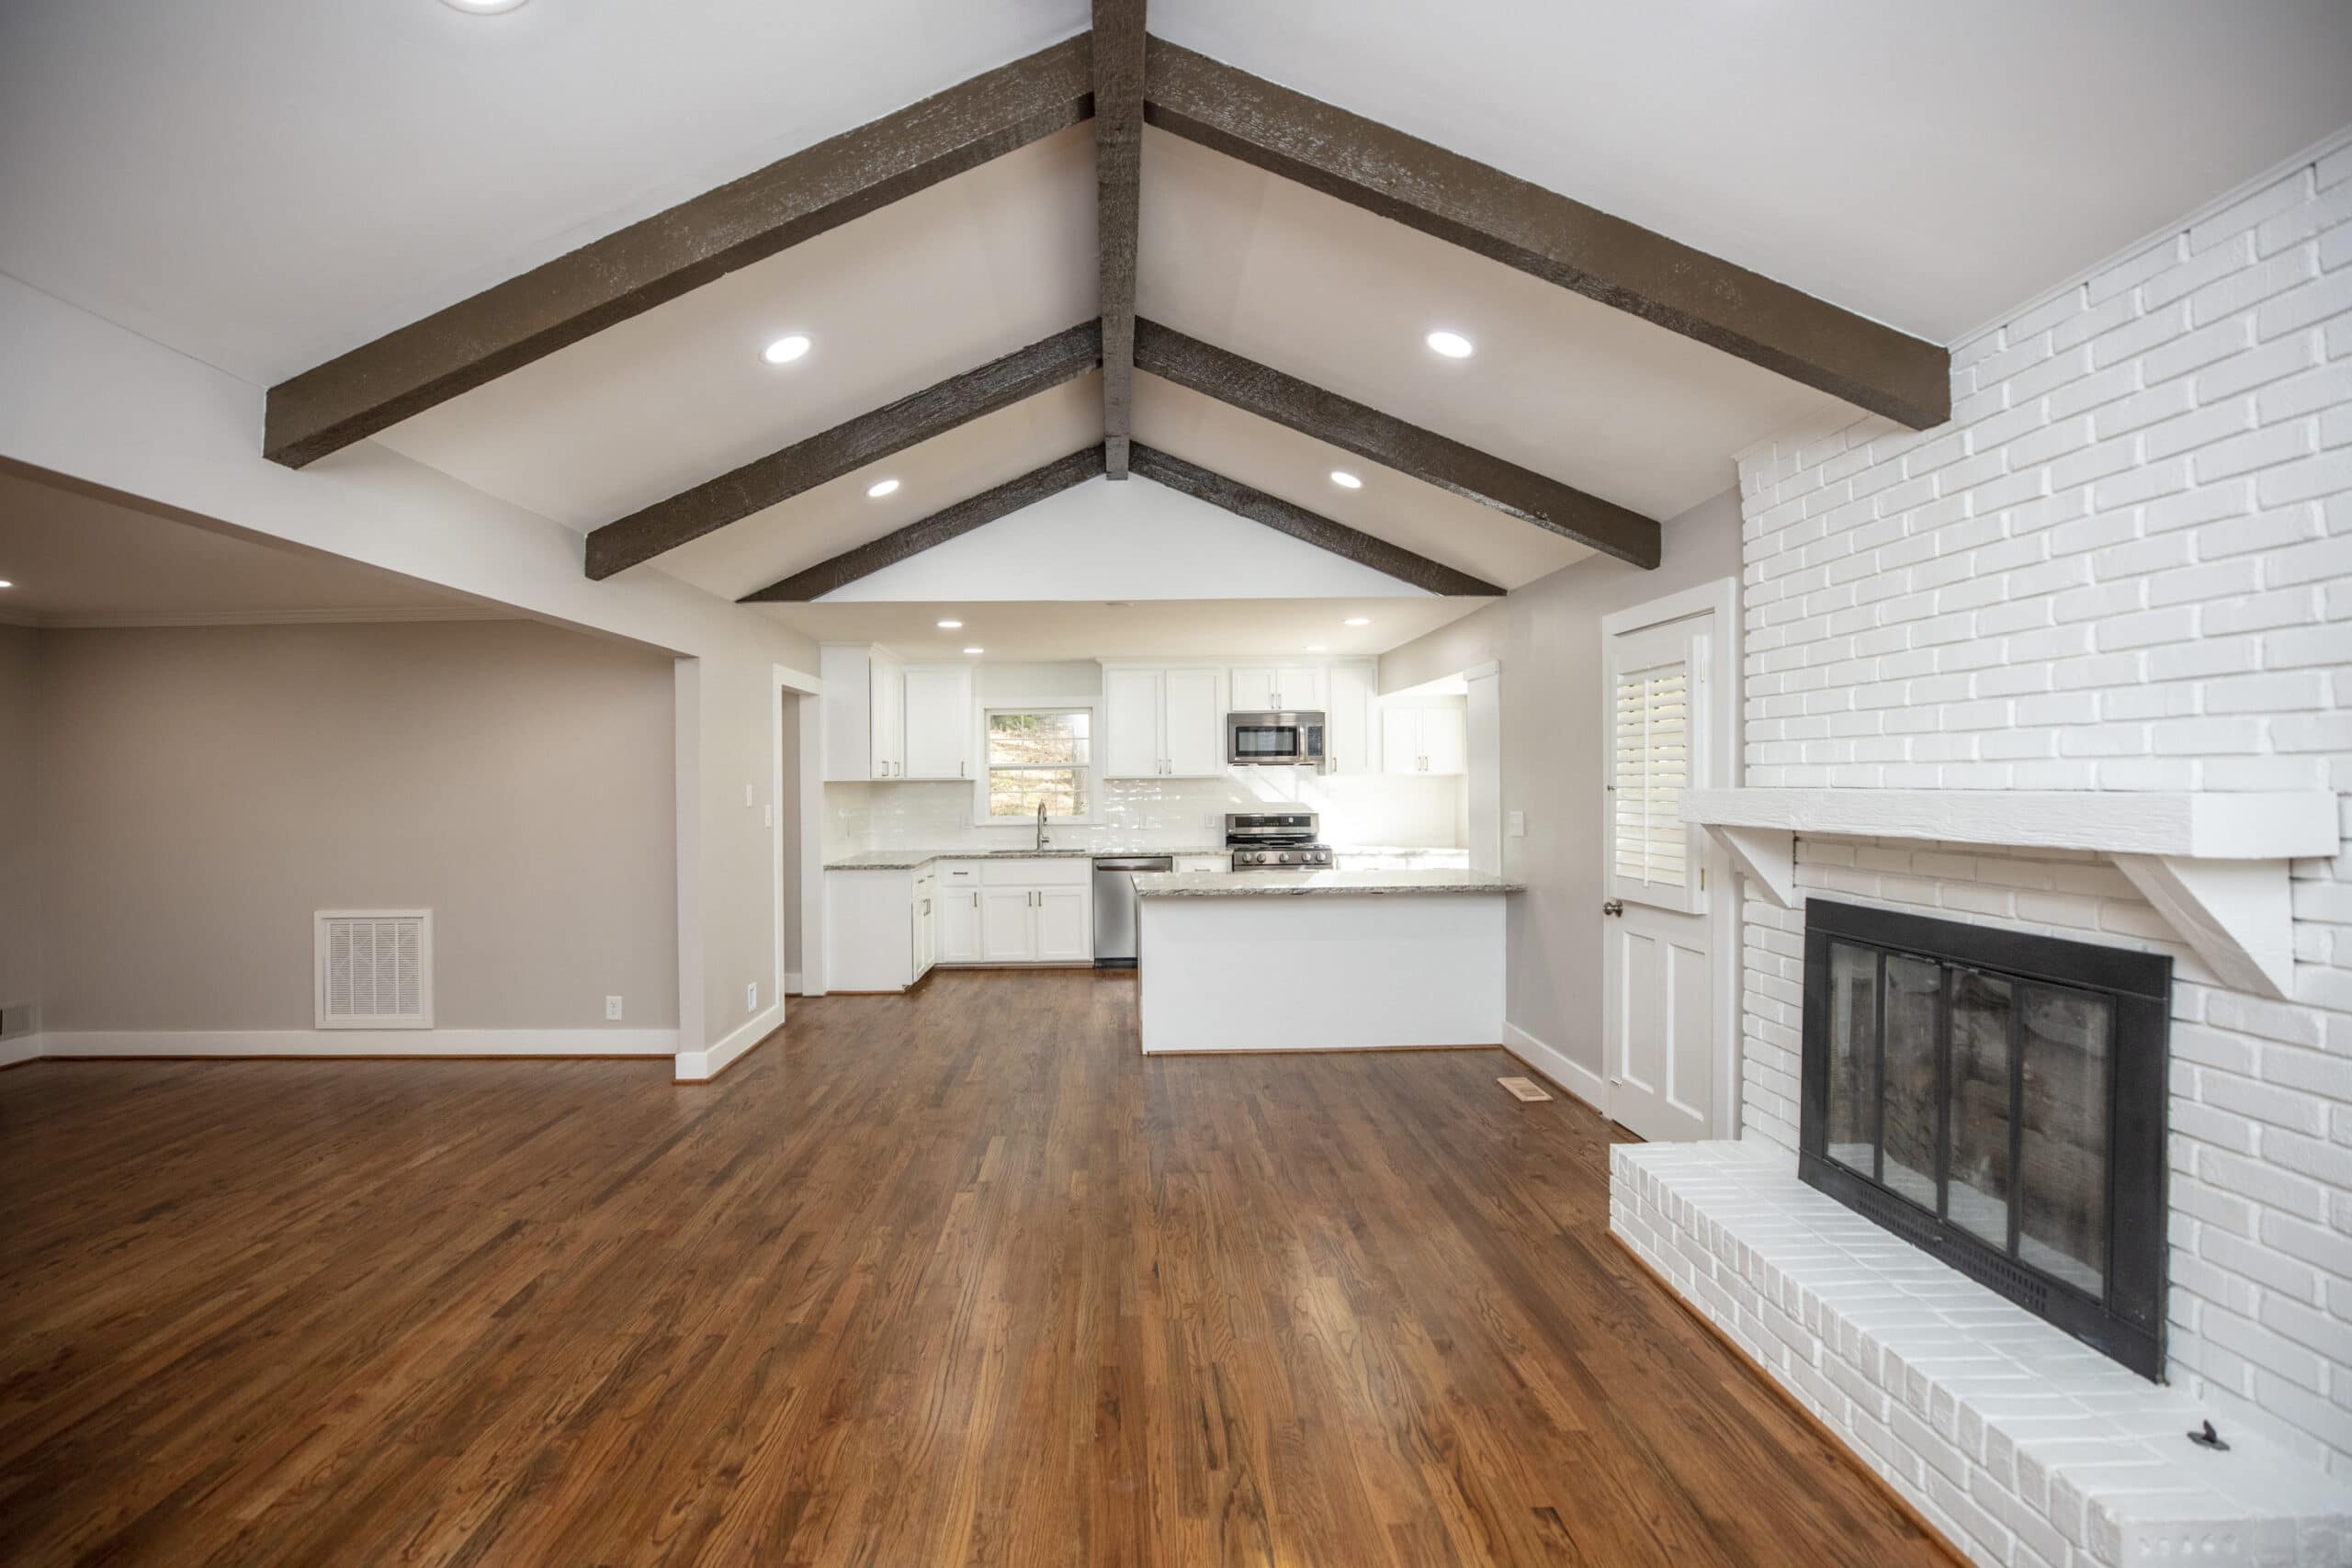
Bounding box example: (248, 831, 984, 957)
(0, 277, 816, 1072)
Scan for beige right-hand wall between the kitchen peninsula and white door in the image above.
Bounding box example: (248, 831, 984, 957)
(1381, 489, 1740, 1072)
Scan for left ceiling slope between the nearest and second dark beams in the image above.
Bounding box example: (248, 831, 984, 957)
(377, 125, 1099, 529)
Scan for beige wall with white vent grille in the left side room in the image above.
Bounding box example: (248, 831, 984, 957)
(40, 621, 682, 1030)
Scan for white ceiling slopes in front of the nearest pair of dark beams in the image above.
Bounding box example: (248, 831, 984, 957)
(0, 0, 2352, 400)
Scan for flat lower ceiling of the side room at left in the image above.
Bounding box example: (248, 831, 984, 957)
(0, 470, 494, 626)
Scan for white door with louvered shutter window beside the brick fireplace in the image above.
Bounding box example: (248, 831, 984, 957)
(1601, 614, 1714, 1140)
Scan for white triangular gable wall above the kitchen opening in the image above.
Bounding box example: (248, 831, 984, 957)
(823, 478, 1430, 604)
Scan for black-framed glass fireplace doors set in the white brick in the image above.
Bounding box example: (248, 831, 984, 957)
(1799, 898, 2171, 1378)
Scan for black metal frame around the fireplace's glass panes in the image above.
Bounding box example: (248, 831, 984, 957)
(1797, 898, 2173, 1382)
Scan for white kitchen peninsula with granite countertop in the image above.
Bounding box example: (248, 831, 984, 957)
(1136, 870, 1524, 1054)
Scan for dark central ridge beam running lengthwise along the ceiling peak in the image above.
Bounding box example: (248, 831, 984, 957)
(1093, 0, 1143, 479)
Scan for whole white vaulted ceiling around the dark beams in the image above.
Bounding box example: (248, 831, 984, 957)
(0, 0, 2352, 651)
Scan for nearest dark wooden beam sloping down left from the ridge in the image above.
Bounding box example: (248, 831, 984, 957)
(261, 33, 1093, 468)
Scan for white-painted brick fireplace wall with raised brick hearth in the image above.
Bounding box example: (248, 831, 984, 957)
(1618, 136, 2352, 1563)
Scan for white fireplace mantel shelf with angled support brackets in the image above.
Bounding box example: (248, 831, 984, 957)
(1681, 790, 2338, 999)
